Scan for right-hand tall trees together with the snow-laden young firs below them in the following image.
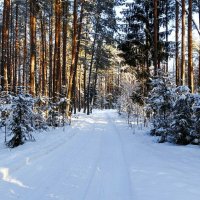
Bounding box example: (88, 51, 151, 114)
(119, 0, 200, 144)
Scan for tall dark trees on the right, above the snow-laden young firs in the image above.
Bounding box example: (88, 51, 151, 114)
(119, 0, 200, 93)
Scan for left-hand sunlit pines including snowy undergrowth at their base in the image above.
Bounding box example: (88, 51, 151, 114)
(0, 0, 122, 146)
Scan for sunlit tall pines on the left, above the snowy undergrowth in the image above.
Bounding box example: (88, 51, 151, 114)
(0, 0, 122, 113)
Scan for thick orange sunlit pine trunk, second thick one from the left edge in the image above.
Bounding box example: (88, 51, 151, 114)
(30, 0, 36, 96)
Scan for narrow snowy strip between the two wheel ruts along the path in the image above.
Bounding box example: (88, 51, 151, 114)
(82, 113, 134, 200)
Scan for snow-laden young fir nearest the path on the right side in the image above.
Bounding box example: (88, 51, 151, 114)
(147, 72, 175, 142)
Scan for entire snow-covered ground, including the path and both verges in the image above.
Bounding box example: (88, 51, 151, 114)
(0, 111, 200, 200)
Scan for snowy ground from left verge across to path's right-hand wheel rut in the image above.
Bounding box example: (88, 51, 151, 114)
(0, 111, 133, 200)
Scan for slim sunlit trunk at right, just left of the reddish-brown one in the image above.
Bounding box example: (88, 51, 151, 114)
(181, 0, 186, 85)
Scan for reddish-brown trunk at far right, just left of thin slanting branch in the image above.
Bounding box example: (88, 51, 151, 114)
(188, 0, 194, 93)
